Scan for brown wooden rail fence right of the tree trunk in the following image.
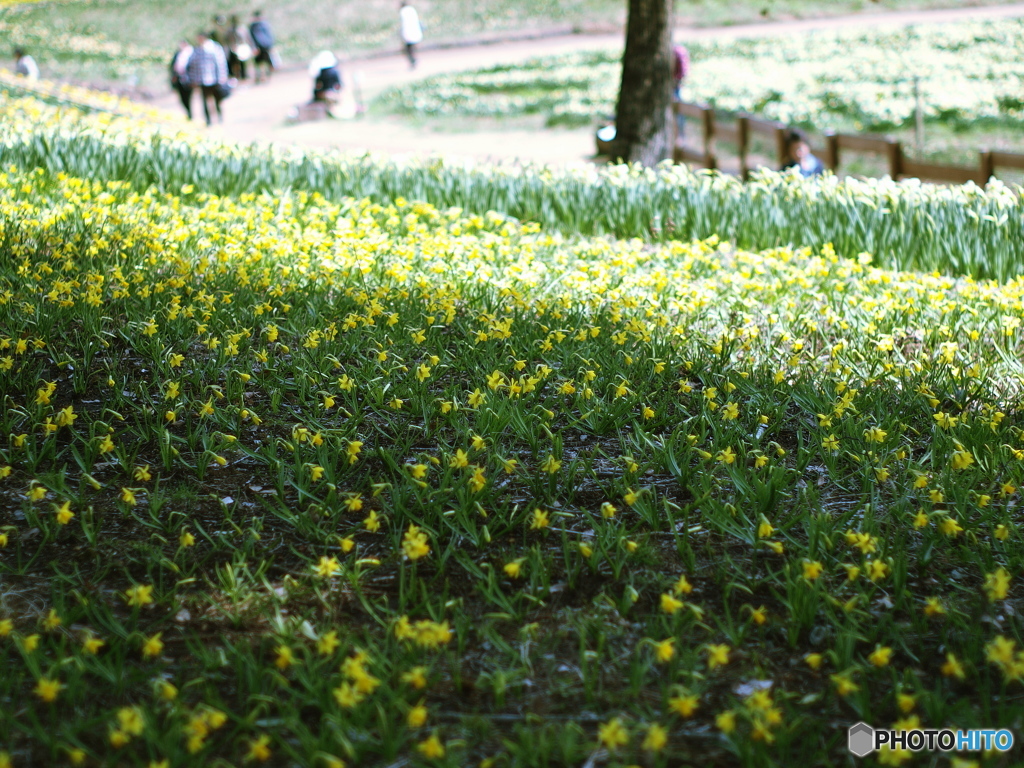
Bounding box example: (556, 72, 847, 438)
(673, 102, 1024, 184)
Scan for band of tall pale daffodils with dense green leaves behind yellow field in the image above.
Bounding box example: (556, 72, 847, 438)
(0, 99, 1024, 279)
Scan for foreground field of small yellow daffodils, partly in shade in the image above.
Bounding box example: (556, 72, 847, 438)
(0, 91, 1024, 768)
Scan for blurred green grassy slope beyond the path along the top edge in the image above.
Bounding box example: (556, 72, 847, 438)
(8, 0, 1024, 88)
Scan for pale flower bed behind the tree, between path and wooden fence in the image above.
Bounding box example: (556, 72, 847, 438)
(384, 19, 1024, 130)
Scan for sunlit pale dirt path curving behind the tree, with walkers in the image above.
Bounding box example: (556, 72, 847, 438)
(148, 3, 1024, 164)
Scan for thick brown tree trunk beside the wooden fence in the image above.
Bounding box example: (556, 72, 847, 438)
(614, 0, 673, 166)
